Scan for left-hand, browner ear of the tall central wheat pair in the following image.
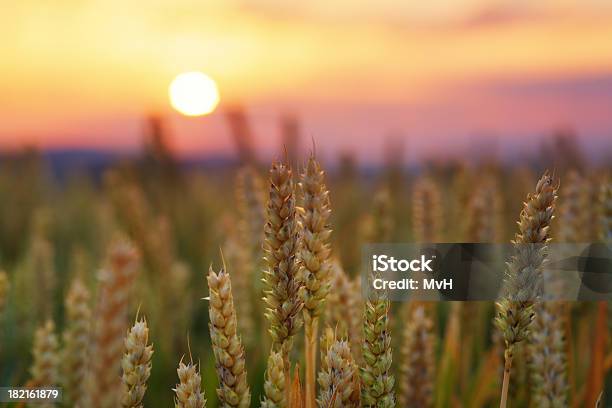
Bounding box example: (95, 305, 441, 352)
(263, 162, 304, 399)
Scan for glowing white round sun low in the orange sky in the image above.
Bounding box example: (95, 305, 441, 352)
(168, 71, 219, 116)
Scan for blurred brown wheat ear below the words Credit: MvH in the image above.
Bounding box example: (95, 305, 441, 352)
(399, 304, 436, 408)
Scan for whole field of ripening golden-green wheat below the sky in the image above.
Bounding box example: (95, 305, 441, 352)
(0, 138, 612, 408)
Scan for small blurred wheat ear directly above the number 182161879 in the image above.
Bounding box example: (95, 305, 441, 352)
(30, 319, 60, 407)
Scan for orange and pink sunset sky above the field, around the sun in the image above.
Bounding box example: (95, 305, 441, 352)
(0, 0, 612, 163)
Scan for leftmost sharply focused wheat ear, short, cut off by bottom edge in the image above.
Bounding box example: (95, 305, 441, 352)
(121, 318, 153, 408)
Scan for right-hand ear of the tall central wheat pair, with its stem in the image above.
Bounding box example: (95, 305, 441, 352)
(299, 155, 331, 408)
